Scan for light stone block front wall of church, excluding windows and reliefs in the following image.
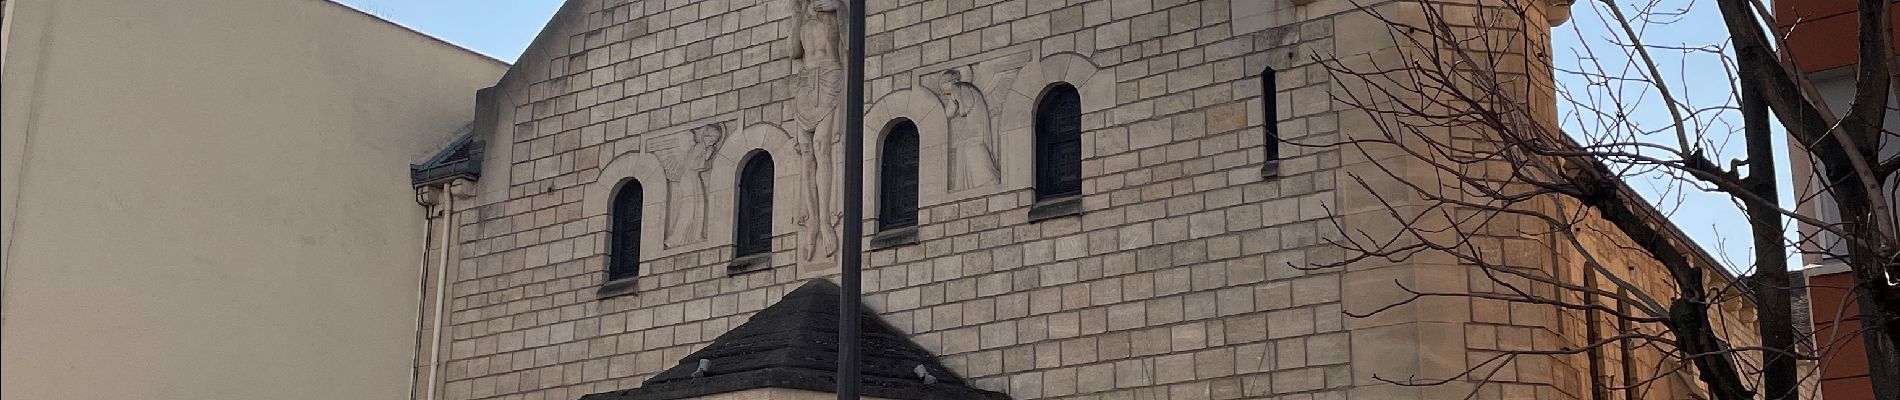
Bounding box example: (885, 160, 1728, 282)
(431, 0, 1740, 400)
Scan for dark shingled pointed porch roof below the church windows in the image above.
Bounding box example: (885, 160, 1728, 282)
(581, 279, 1009, 400)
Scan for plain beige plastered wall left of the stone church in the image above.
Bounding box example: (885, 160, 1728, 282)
(0, 0, 507, 400)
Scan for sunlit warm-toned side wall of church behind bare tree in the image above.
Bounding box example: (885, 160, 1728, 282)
(1535, 192, 1761, 400)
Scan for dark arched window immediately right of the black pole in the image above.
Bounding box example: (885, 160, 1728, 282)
(878, 121, 918, 231)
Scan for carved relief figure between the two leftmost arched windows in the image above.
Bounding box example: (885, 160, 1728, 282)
(659, 123, 726, 246)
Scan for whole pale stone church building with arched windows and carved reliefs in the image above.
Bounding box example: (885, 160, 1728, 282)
(400, 0, 1746, 400)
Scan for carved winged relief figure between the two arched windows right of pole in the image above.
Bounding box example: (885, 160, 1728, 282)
(923, 53, 1030, 190)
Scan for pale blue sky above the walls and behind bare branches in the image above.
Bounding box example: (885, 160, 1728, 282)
(338, 0, 1792, 273)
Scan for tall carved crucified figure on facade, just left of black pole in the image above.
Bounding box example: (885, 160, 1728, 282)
(790, 0, 844, 262)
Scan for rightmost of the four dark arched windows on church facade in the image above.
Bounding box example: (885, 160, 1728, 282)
(1036, 83, 1081, 199)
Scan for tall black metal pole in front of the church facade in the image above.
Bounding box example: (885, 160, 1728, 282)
(838, 0, 865, 400)
